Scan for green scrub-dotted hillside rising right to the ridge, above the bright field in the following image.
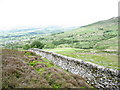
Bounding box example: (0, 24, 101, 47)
(42, 17, 118, 50)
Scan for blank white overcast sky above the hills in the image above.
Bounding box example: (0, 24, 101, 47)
(0, 0, 119, 30)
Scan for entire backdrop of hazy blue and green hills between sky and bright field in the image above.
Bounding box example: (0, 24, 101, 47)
(0, 17, 118, 51)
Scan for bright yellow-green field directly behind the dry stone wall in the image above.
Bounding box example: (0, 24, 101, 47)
(45, 48, 119, 69)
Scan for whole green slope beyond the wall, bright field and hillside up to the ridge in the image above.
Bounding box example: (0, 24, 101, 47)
(43, 17, 120, 69)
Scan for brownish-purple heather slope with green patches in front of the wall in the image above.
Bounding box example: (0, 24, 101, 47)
(2, 49, 91, 89)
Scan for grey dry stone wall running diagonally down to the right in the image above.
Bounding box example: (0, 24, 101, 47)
(29, 48, 120, 88)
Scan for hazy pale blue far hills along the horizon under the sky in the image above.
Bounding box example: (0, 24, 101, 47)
(0, 26, 76, 38)
